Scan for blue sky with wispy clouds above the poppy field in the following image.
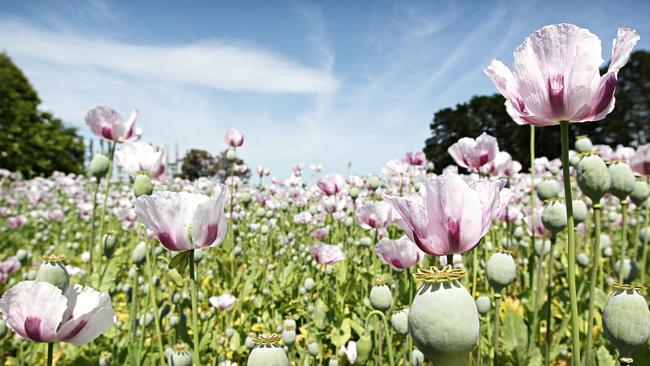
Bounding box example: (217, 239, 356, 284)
(0, 0, 650, 176)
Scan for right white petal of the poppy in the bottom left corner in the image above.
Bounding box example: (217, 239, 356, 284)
(56, 285, 115, 344)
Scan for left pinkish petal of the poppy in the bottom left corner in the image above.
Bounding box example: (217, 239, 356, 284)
(0, 281, 68, 342)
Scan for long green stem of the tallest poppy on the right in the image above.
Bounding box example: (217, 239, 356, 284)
(560, 121, 580, 366)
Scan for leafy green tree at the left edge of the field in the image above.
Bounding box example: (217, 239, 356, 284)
(0, 54, 84, 177)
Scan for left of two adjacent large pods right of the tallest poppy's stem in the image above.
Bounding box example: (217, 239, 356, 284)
(576, 155, 611, 202)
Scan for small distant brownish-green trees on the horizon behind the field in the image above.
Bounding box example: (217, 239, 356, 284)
(180, 149, 250, 182)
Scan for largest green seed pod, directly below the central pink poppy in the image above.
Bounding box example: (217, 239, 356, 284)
(409, 279, 479, 365)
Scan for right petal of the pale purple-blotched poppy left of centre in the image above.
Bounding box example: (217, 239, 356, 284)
(192, 184, 228, 248)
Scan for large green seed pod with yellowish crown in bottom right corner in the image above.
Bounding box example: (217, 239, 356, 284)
(603, 288, 650, 358)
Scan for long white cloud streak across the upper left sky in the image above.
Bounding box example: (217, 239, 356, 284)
(0, 21, 338, 93)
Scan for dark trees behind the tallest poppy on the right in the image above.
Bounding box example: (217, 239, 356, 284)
(424, 51, 650, 172)
